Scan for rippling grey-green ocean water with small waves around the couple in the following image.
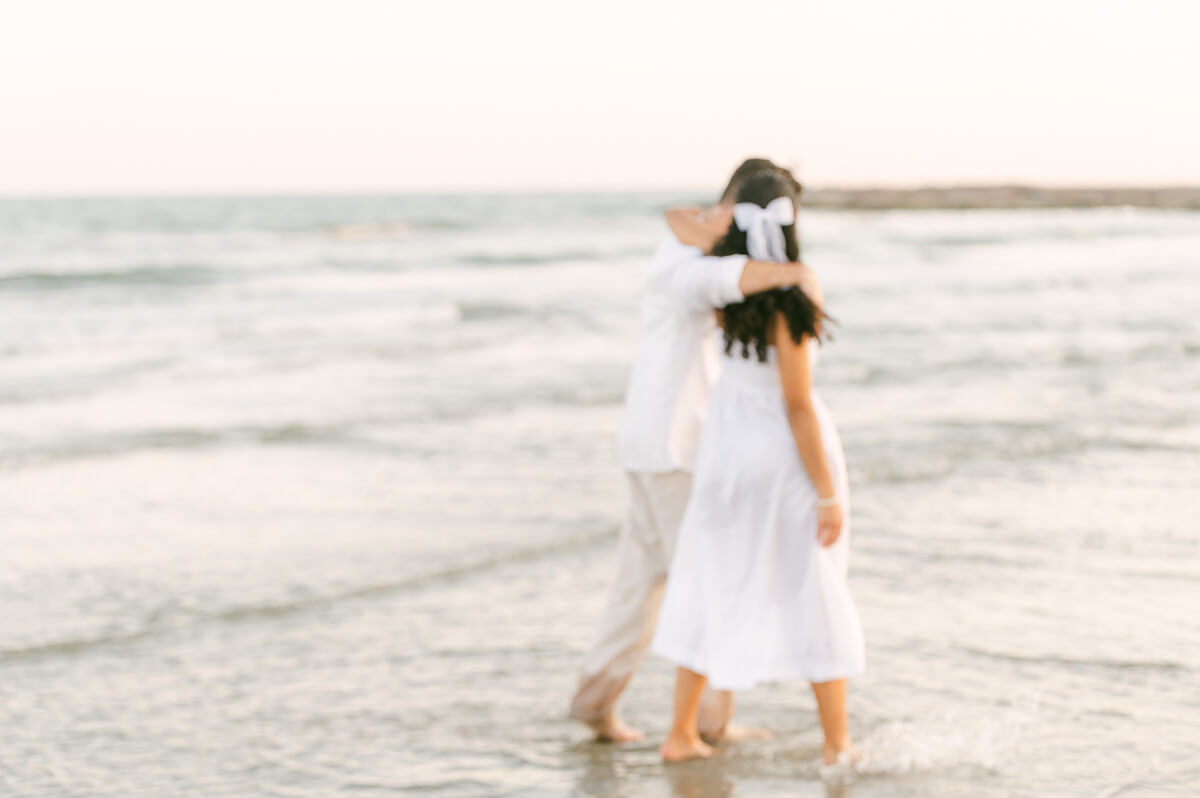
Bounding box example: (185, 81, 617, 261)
(0, 194, 1200, 798)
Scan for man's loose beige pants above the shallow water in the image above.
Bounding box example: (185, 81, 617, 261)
(571, 472, 733, 737)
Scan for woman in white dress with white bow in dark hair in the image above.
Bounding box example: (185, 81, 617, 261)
(654, 172, 864, 762)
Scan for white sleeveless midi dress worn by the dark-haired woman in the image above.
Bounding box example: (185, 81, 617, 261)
(653, 340, 865, 690)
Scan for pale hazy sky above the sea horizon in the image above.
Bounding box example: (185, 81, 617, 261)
(0, 0, 1200, 194)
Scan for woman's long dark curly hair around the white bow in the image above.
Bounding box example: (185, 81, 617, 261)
(712, 169, 832, 362)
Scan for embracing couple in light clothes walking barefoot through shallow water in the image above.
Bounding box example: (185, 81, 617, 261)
(571, 158, 864, 763)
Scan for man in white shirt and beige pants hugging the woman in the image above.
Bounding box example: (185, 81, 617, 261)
(570, 158, 808, 742)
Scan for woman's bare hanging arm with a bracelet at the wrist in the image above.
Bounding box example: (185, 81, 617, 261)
(775, 313, 842, 546)
